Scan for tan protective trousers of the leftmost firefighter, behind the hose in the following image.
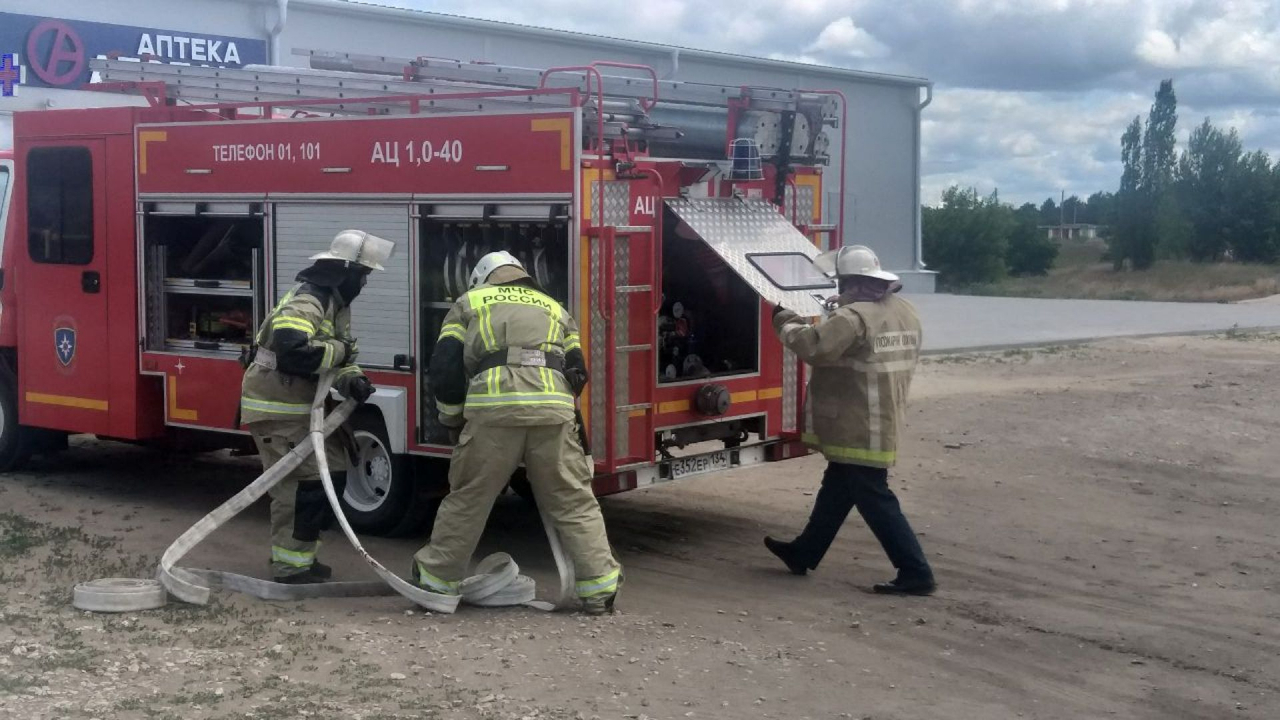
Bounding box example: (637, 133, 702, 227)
(248, 416, 347, 578)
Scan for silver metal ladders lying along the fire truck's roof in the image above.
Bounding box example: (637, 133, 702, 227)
(90, 50, 844, 154)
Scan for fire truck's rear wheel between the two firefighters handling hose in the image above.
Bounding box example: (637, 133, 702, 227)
(339, 411, 438, 537)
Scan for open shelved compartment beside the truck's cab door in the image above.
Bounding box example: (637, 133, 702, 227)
(142, 201, 264, 355)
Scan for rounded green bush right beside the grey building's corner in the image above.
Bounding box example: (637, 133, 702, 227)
(920, 187, 1012, 287)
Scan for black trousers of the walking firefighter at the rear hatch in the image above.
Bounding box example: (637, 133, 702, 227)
(791, 462, 933, 580)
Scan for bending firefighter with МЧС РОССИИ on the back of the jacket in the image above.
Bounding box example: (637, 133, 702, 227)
(413, 252, 622, 614)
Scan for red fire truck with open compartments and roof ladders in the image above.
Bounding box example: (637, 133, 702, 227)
(0, 55, 844, 534)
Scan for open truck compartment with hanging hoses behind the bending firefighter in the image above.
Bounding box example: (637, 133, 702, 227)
(417, 201, 570, 445)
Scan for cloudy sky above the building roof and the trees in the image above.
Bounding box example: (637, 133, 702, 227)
(381, 0, 1280, 202)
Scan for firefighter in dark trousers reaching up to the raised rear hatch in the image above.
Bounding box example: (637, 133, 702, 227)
(764, 246, 936, 594)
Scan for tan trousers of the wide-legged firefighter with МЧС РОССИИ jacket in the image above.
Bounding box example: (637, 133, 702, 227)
(413, 421, 620, 597)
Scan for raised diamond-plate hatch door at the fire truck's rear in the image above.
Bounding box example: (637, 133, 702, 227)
(667, 197, 836, 318)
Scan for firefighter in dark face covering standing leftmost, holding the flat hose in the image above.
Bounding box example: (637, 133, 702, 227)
(241, 231, 396, 583)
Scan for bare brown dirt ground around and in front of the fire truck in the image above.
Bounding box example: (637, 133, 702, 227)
(0, 336, 1280, 720)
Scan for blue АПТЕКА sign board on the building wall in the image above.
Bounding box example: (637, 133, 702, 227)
(0, 13, 266, 88)
